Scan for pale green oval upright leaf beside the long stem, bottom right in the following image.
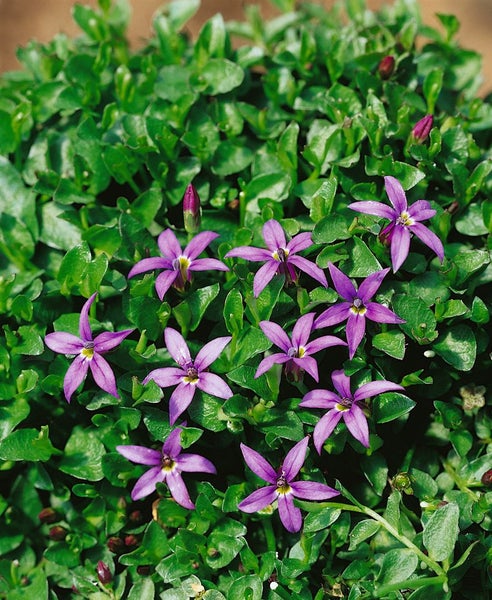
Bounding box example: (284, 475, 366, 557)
(422, 502, 460, 561)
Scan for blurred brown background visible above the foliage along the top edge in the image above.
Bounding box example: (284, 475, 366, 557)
(0, 0, 492, 92)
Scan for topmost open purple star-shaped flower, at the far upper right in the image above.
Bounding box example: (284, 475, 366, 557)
(349, 176, 444, 273)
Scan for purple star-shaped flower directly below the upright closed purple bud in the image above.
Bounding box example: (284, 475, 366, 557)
(128, 229, 229, 300)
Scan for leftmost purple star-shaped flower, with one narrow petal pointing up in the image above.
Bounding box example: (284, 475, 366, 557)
(44, 292, 133, 402)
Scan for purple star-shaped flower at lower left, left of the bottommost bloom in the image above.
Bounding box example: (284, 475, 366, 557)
(116, 428, 217, 509)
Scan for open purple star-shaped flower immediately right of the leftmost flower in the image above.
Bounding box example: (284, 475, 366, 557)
(143, 327, 233, 425)
